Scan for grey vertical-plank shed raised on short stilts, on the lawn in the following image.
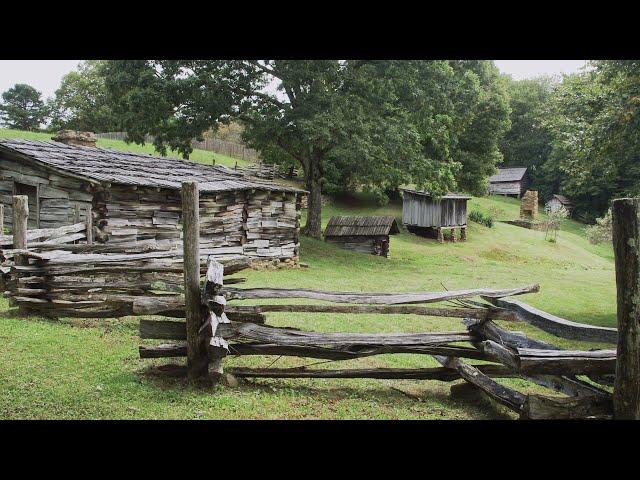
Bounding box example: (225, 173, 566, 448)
(402, 189, 471, 242)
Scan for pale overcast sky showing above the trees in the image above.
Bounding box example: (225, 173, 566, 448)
(0, 60, 585, 97)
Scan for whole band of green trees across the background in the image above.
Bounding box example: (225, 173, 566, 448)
(0, 60, 640, 232)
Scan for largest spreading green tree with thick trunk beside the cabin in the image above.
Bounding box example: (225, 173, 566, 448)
(105, 60, 508, 237)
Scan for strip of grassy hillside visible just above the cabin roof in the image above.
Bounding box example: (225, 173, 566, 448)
(0, 128, 249, 168)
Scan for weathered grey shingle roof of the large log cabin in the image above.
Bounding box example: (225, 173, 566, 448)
(0, 139, 303, 192)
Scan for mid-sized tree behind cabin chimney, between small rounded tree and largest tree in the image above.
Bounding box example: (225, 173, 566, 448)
(49, 60, 119, 132)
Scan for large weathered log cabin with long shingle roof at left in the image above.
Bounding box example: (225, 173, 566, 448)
(0, 132, 304, 260)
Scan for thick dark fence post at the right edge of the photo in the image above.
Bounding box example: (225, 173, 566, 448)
(612, 198, 640, 420)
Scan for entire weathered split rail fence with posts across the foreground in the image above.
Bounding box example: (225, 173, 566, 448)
(2, 189, 640, 419)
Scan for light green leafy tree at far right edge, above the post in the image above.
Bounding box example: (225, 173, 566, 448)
(543, 60, 640, 218)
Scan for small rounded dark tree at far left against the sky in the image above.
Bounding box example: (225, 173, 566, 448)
(0, 83, 47, 130)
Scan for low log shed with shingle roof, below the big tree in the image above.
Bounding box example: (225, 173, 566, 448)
(324, 216, 400, 257)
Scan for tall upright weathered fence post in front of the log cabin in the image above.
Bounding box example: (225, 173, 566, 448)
(182, 182, 209, 380)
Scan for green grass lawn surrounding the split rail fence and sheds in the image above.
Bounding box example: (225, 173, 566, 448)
(0, 129, 616, 419)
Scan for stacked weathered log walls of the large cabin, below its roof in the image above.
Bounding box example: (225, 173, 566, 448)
(0, 154, 301, 260)
